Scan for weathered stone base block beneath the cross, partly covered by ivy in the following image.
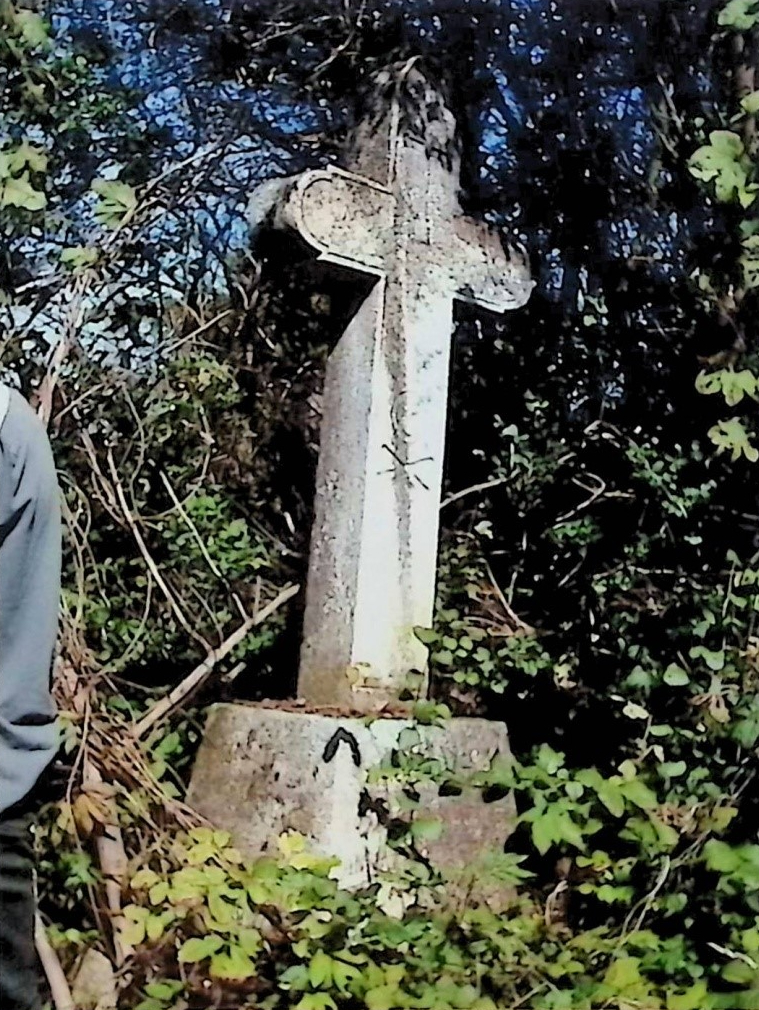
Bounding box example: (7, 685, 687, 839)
(188, 705, 515, 900)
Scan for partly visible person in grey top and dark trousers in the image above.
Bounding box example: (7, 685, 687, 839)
(0, 394, 61, 1010)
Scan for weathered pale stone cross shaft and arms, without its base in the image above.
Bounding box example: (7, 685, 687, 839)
(277, 71, 533, 712)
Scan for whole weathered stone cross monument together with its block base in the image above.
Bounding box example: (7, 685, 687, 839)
(190, 70, 532, 886)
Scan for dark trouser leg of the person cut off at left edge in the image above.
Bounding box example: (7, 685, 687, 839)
(0, 807, 40, 1010)
